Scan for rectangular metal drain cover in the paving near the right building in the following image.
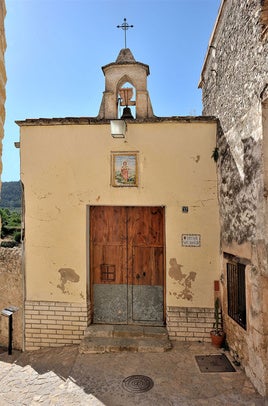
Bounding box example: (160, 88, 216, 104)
(195, 354, 236, 372)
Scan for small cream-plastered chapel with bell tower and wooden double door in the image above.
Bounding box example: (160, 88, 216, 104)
(17, 49, 219, 349)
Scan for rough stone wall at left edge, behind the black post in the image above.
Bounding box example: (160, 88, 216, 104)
(0, 247, 23, 350)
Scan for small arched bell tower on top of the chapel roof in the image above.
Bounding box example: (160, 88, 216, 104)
(98, 48, 154, 120)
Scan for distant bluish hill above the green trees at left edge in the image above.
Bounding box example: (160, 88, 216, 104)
(0, 181, 22, 210)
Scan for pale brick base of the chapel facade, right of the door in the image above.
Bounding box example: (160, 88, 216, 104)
(167, 306, 214, 342)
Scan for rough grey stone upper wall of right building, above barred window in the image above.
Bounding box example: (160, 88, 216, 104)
(200, 0, 268, 243)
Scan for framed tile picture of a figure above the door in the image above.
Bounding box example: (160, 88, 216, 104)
(111, 152, 138, 187)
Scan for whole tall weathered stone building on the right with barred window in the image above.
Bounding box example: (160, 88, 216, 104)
(199, 0, 268, 395)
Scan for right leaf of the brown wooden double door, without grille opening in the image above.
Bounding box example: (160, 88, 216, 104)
(128, 207, 164, 323)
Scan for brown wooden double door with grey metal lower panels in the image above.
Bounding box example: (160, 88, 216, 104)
(90, 206, 164, 325)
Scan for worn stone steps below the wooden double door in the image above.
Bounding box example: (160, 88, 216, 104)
(79, 324, 172, 354)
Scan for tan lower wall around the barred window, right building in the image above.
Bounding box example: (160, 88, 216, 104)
(222, 249, 268, 395)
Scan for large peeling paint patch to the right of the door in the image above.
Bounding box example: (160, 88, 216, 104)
(169, 258, 196, 301)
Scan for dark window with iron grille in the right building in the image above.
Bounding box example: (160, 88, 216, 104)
(227, 263, 247, 330)
